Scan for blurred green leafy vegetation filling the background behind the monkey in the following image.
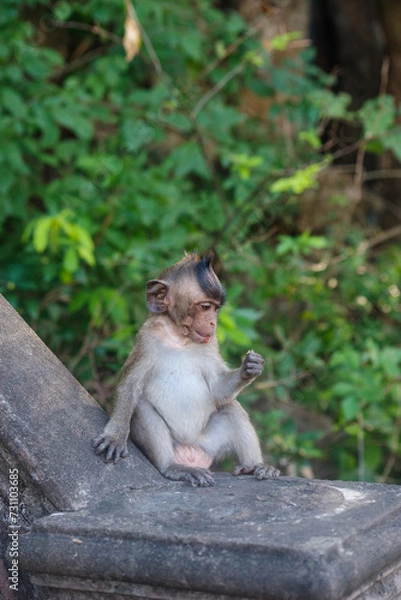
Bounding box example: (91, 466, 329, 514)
(0, 0, 401, 482)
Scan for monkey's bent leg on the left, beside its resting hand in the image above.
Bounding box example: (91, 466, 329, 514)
(131, 402, 214, 487)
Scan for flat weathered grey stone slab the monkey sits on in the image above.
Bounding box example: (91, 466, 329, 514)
(18, 474, 401, 600)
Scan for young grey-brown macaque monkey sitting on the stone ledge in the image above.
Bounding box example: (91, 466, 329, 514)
(93, 253, 280, 486)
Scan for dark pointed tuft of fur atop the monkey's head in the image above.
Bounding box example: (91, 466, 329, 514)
(160, 252, 226, 304)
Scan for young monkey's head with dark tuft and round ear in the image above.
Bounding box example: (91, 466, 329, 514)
(146, 253, 225, 344)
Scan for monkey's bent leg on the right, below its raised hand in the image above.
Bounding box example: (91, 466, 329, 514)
(199, 400, 280, 479)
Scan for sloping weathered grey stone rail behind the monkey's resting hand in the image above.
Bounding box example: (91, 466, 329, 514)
(0, 295, 163, 510)
